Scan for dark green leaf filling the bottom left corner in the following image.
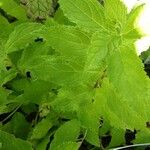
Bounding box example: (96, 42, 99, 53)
(0, 131, 33, 150)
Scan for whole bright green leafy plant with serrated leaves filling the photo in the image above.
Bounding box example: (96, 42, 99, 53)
(0, 0, 150, 150)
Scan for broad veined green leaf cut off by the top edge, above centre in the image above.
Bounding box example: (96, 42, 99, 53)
(59, 0, 106, 31)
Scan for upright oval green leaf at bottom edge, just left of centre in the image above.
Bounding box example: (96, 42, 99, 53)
(50, 120, 80, 150)
